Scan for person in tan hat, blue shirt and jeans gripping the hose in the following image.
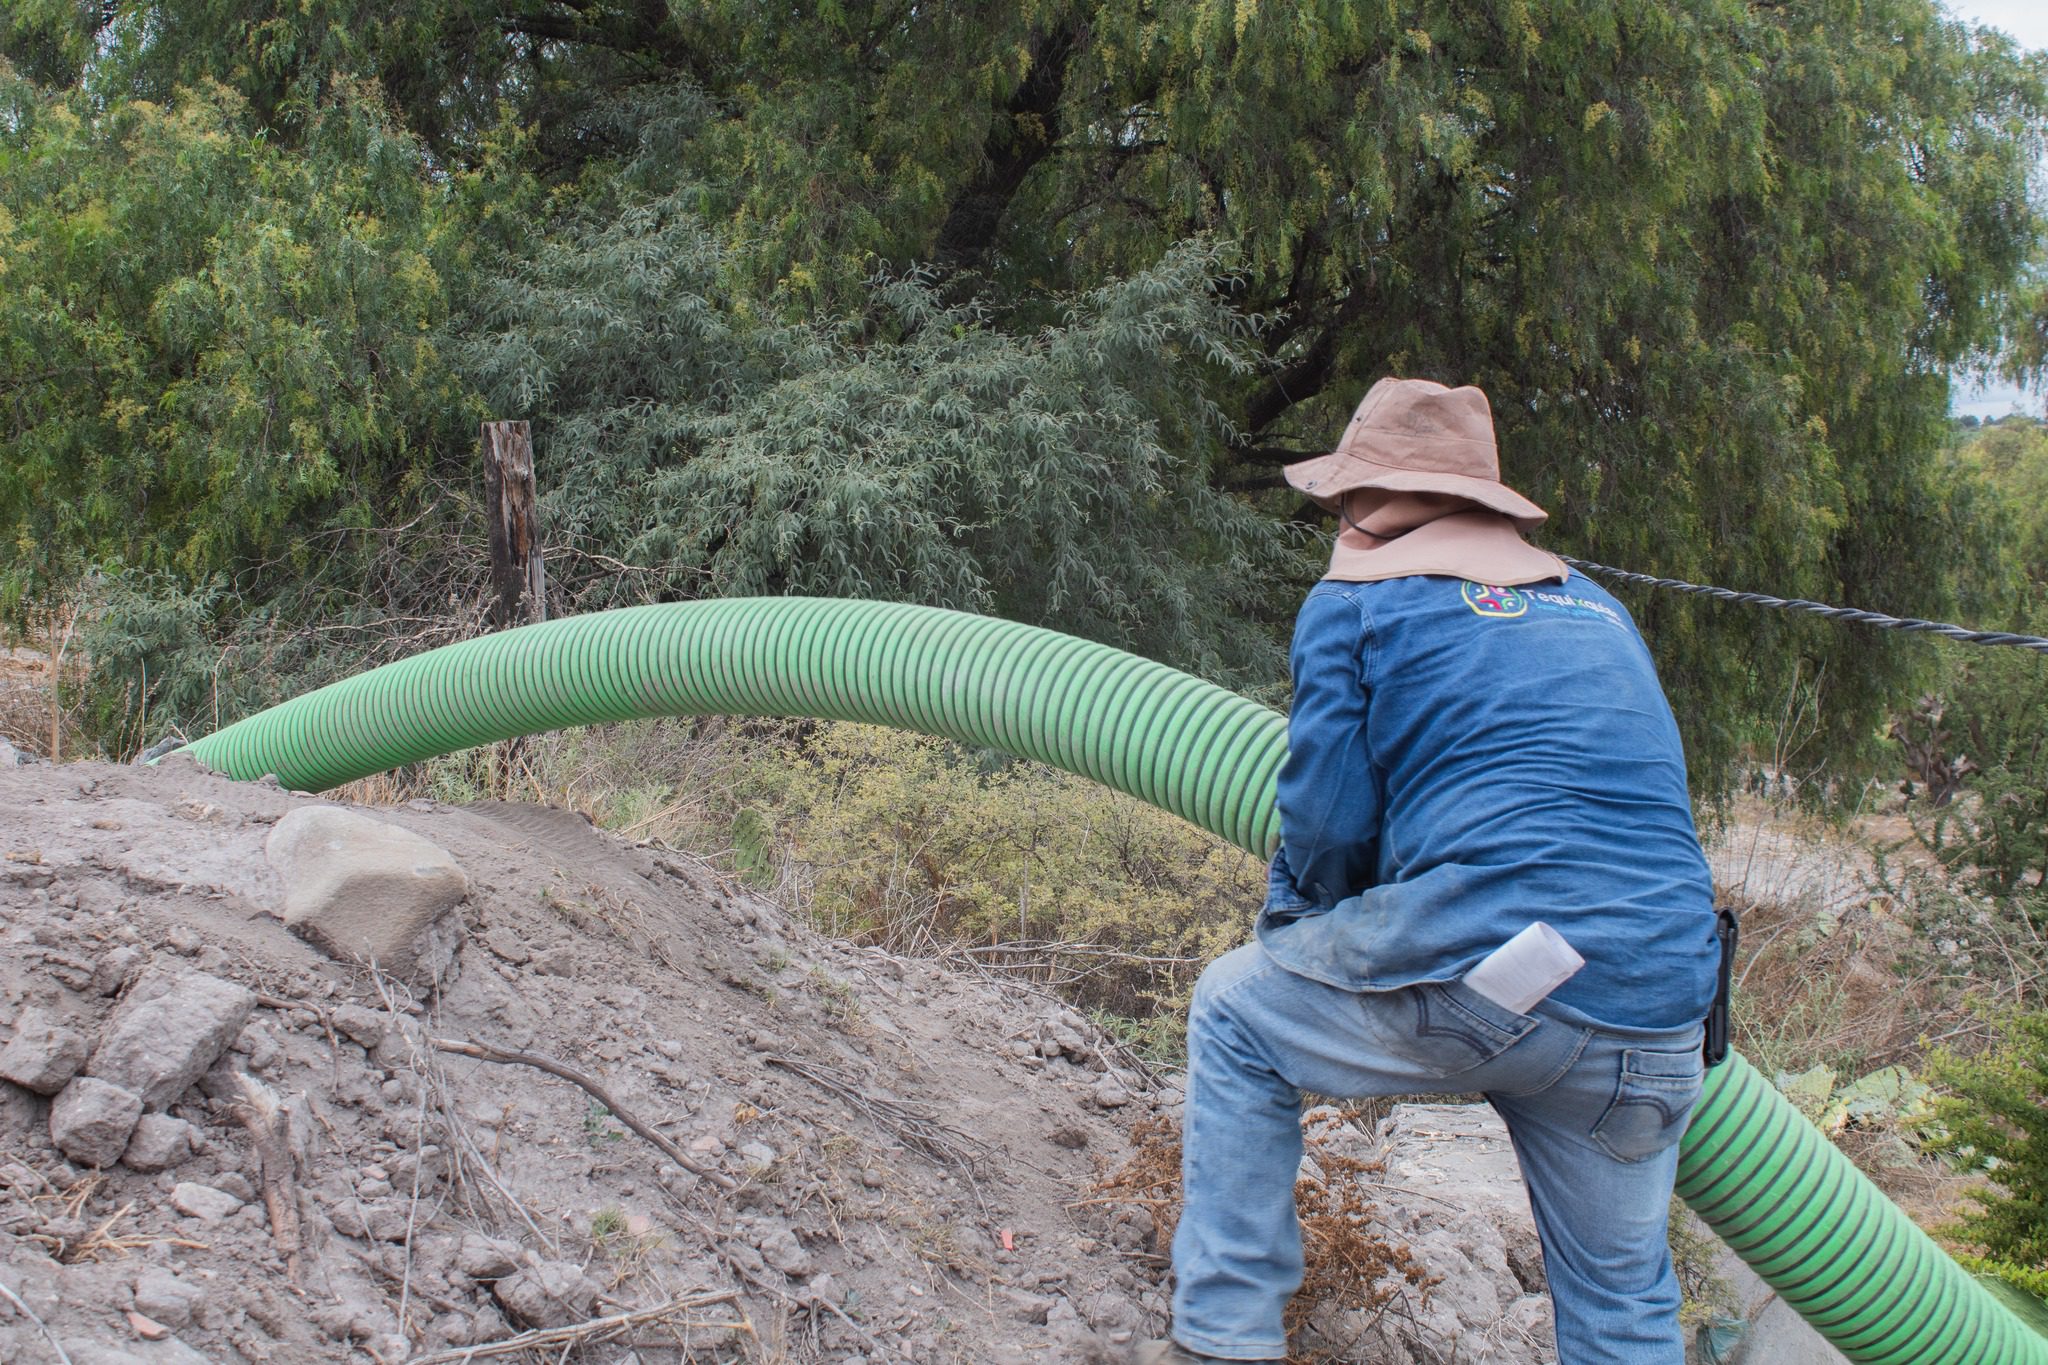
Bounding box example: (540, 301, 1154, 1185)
(1139, 379, 1720, 1365)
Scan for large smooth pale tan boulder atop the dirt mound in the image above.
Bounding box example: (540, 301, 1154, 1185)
(264, 806, 469, 982)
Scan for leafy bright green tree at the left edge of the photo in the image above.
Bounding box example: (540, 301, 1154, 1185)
(0, 73, 469, 610)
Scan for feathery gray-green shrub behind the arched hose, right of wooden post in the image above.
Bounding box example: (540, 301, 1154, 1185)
(469, 209, 1288, 675)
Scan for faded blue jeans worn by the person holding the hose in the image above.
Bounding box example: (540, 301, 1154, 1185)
(1174, 943, 1702, 1365)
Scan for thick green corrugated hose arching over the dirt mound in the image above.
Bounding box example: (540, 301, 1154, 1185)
(182, 598, 2048, 1365)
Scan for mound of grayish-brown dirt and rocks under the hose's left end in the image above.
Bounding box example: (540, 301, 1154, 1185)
(0, 755, 1550, 1365)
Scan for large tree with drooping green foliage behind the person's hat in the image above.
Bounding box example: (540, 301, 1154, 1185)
(0, 0, 2048, 786)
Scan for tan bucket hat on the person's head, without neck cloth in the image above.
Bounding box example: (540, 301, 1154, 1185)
(1286, 379, 1550, 530)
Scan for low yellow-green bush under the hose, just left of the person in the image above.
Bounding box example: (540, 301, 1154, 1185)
(753, 724, 1266, 1017)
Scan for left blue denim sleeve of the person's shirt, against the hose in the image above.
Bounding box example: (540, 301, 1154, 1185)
(1266, 591, 1380, 911)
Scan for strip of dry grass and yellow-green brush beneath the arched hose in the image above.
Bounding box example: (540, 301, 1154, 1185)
(516, 718, 1266, 1054)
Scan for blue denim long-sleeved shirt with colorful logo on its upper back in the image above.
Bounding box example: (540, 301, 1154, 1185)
(1257, 575, 1718, 1029)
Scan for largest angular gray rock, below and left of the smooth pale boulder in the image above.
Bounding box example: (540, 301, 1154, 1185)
(86, 970, 256, 1113)
